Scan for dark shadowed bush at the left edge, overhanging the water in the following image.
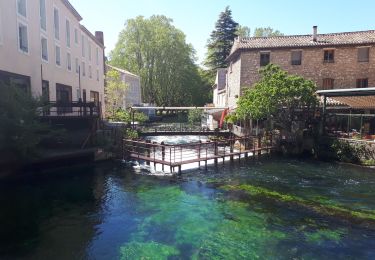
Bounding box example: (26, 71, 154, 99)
(0, 82, 50, 161)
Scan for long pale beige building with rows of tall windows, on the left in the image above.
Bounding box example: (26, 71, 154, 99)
(0, 0, 104, 112)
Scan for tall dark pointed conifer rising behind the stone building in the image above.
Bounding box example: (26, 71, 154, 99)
(204, 6, 238, 73)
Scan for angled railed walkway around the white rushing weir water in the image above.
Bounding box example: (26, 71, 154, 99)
(123, 135, 276, 173)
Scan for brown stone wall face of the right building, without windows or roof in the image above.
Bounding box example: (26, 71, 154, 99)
(239, 46, 375, 92)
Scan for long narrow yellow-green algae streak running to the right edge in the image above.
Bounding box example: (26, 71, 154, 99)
(221, 184, 375, 226)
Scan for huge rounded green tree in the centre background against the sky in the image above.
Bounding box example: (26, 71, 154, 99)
(110, 15, 206, 106)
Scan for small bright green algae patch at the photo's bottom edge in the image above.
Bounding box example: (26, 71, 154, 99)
(120, 241, 180, 260)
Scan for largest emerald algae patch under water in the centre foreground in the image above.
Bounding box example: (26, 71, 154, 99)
(122, 186, 286, 259)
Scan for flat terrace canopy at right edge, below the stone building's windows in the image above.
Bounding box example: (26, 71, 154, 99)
(316, 88, 375, 109)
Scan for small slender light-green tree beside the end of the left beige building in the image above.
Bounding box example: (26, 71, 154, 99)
(105, 69, 128, 121)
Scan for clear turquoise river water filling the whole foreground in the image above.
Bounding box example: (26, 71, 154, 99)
(0, 158, 375, 259)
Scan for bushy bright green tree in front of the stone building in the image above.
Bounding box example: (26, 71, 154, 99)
(236, 64, 317, 132)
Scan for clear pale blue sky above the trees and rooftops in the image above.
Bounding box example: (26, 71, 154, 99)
(70, 0, 375, 64)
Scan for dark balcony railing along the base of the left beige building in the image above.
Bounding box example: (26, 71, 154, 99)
(38, 101, 100, 117)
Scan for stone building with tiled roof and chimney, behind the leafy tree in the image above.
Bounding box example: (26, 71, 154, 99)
(226, 26, 375, 108)
